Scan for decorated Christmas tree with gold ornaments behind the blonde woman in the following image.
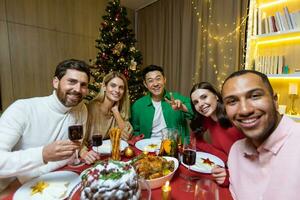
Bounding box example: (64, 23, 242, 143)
(87, 0, 144, 103)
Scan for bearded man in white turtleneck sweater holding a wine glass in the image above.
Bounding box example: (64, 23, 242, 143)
(0, 59, 90, 192)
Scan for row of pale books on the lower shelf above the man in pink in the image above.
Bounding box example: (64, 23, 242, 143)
(254, 55, 284, 74)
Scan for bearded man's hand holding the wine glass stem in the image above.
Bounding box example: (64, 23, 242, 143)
(42, 140, 80, 163)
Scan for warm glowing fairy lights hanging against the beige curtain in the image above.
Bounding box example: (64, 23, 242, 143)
(191, 0, 248, 86)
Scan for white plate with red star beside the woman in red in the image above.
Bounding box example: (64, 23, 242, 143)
(181, 152, 225, 174)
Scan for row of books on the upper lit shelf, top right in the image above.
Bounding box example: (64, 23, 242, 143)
(253, 6, 300, 35)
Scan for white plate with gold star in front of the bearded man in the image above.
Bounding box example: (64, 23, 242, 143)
(13, 171, 81, 200)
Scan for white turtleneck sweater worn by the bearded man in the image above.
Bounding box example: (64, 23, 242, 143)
(0, 91, 87, 191)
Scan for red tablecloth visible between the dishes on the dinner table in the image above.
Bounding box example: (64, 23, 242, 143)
(3, 146, 232, 200)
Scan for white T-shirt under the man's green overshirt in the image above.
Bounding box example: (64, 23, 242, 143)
(151, 100, 167, 138)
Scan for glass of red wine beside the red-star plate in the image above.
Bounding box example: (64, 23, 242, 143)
(182, 133, 196, 192)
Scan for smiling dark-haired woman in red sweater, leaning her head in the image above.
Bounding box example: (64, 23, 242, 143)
(190, 82, 244, 182)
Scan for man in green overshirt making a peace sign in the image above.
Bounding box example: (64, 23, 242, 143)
(131, 65, 193, 138)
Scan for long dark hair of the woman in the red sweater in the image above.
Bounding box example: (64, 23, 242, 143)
(190, 82, 232, 131)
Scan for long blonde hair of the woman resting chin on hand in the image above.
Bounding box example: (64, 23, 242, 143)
(92, 71, 130, 120)
